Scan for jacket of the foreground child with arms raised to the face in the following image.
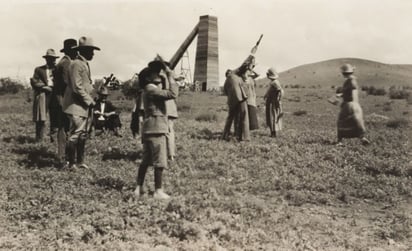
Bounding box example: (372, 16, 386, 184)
(142, 79, 178, 134)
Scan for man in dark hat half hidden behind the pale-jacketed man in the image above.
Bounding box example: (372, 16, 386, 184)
(50, 38, 77, 166)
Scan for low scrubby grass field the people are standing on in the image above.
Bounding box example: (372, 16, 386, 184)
(0, 86, 412, 250)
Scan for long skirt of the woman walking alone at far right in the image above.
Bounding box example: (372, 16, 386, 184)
(338, 102, 366, 139)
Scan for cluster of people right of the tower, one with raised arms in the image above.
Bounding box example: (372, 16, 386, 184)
(222, 55, 283, 141)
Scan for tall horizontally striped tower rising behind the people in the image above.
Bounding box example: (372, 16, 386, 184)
(194, 15, 219, 91)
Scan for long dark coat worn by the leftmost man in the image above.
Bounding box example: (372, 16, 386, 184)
(30, 65, 55, 122)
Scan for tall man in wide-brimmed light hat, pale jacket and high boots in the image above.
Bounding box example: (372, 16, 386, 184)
(63, 37, 100, 168)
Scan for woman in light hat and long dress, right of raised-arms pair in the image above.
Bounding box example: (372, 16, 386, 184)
(263, 68, 283, 137)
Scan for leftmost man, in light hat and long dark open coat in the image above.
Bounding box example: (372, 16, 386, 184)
(30, 49, 58, 141)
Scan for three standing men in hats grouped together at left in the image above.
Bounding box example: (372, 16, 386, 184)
(30, 37, 108, 171)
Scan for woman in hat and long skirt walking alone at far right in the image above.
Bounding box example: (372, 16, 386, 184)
(337, 64, 370, 145)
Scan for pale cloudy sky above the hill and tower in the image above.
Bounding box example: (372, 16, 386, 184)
(0, 0, 412, 83)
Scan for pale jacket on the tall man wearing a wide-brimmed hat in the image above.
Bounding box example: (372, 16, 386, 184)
(63, 55, 93, 117)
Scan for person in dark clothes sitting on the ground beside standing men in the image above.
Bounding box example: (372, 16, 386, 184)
(93, 86, 122, 137)
